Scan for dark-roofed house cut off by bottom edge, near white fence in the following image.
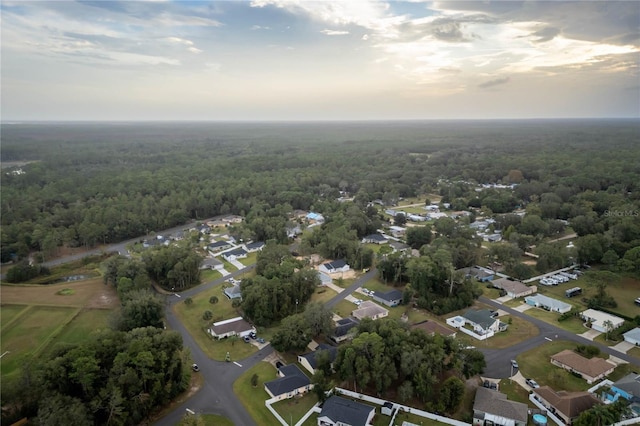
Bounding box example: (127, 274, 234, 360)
(318, 395, 376, 426)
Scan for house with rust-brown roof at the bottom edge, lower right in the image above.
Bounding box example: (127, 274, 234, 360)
(533, 386, 600, 425)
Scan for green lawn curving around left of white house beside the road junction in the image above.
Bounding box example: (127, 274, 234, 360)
(173, 286, 257, 361)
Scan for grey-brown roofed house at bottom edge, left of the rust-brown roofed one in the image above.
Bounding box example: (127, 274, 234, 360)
(472, 387, 529, 426)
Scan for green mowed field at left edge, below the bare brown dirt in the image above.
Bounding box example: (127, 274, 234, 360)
(0, 306, 79, 381)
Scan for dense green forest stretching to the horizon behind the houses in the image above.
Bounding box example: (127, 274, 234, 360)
(0, 120, 640, 261)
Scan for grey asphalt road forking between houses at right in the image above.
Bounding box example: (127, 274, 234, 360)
(479, 297, 640, 379)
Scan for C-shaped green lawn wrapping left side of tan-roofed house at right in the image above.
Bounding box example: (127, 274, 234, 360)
(516, 340, 591, 392)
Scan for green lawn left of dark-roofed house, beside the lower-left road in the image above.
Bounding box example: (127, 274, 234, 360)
(233, 362, 280, 426)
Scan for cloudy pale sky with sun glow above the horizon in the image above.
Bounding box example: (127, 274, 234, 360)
(0, 0, 640, 121)
